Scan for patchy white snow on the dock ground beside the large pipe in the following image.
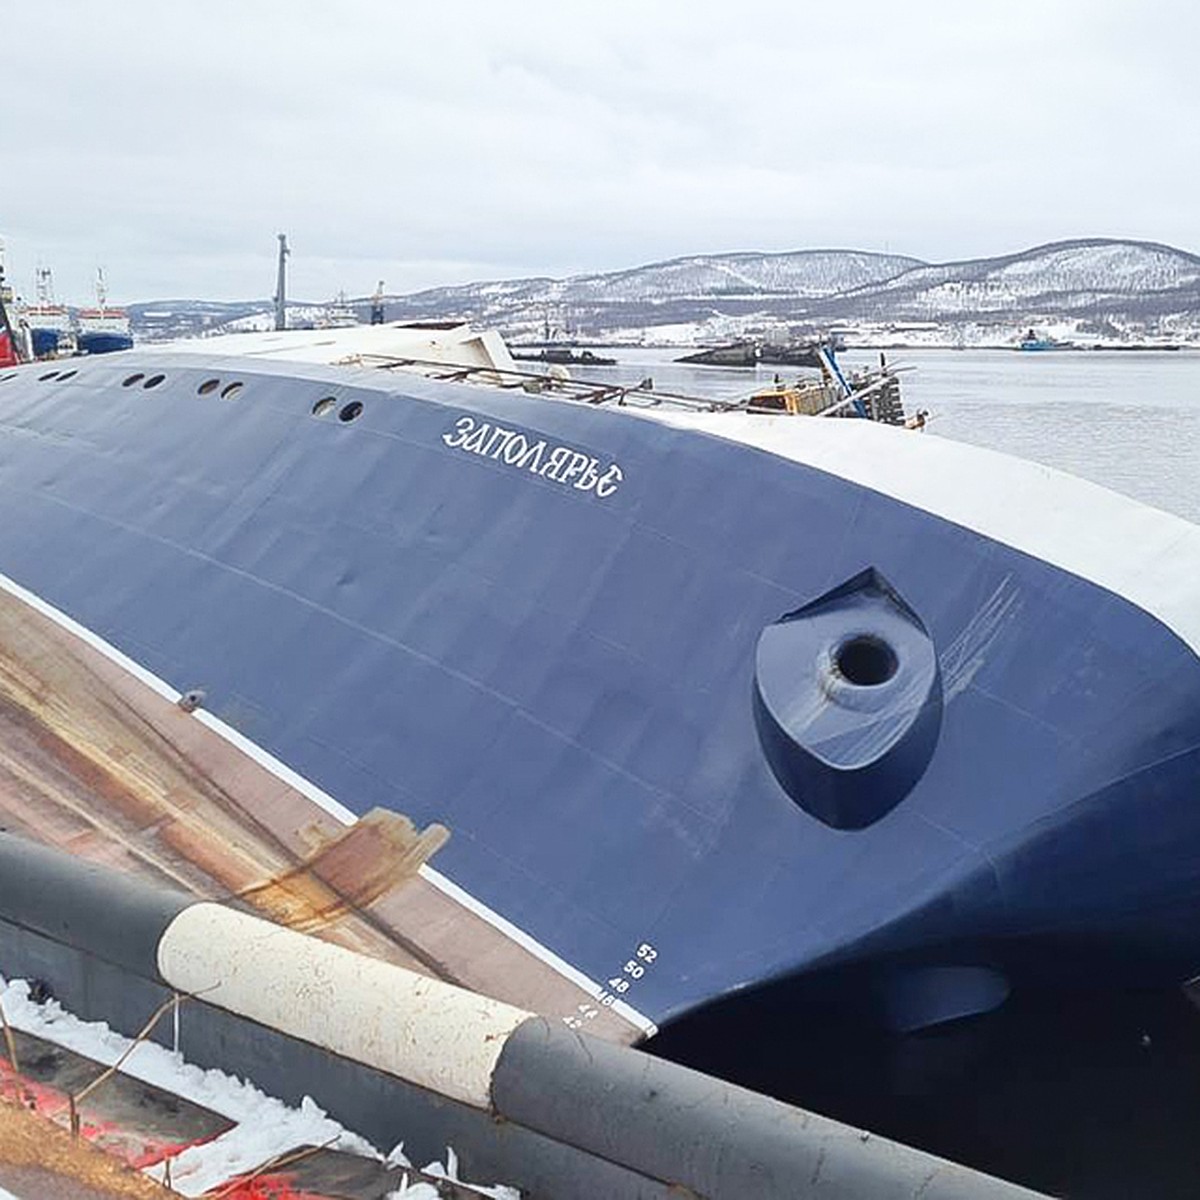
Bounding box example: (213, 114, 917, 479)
(0, 977, 520, 1200)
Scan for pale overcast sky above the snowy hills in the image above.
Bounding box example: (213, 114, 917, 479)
(0, 0, 1200, 302)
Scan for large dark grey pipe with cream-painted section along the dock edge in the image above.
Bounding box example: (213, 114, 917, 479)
(0, 833, 1036, 1200)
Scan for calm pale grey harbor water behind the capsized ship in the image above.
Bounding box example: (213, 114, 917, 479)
(572, 349, 1200, 523)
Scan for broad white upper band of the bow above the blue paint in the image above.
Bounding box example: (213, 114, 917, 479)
(643, 408, 1200, 654)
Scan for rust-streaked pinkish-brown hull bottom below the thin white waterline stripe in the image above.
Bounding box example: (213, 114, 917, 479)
(0, 578, 638, 1042)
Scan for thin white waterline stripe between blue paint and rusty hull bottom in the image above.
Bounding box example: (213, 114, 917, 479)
(0, 575, 658, 1037)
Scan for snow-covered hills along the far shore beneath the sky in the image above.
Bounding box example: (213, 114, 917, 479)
(130, 238, 1200, 343)
